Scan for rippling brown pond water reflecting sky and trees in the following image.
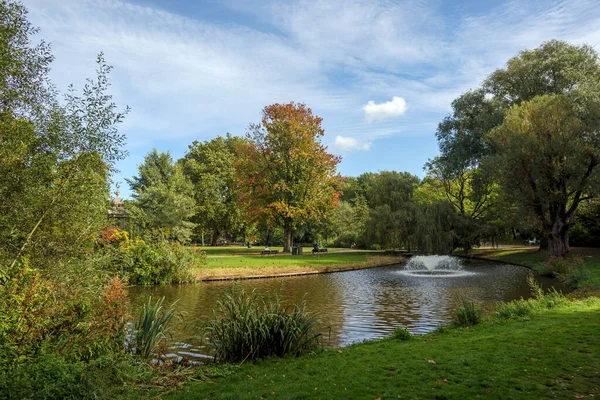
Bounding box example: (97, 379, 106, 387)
(130, 261, 562, 361)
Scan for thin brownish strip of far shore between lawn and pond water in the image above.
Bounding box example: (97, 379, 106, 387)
(195, 256, 406, 283)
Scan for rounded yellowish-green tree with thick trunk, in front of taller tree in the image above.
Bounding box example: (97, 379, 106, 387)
(489, 95, 600, 256)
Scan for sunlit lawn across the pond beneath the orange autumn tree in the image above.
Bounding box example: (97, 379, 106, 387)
(192, 247, 402, 280)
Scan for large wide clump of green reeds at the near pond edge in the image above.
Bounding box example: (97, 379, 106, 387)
(205, 287, 321, 362)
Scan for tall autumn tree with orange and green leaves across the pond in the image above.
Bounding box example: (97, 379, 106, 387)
(236, 102, 341, 252)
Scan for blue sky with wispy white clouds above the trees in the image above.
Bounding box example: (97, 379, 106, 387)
(22, 0, 600, 197)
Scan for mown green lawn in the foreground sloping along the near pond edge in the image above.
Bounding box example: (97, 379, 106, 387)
(165, 299, 600, 399)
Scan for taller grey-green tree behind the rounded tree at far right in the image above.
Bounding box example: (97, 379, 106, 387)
(438, 40, 600, 255)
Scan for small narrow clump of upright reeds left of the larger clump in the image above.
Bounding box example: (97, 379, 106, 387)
(132, 296, 175, 358)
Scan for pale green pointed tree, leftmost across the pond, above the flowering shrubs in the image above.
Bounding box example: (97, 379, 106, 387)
(127, 149, 196, 242)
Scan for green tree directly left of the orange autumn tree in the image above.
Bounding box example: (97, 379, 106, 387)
(181, 134, 245, 246)
